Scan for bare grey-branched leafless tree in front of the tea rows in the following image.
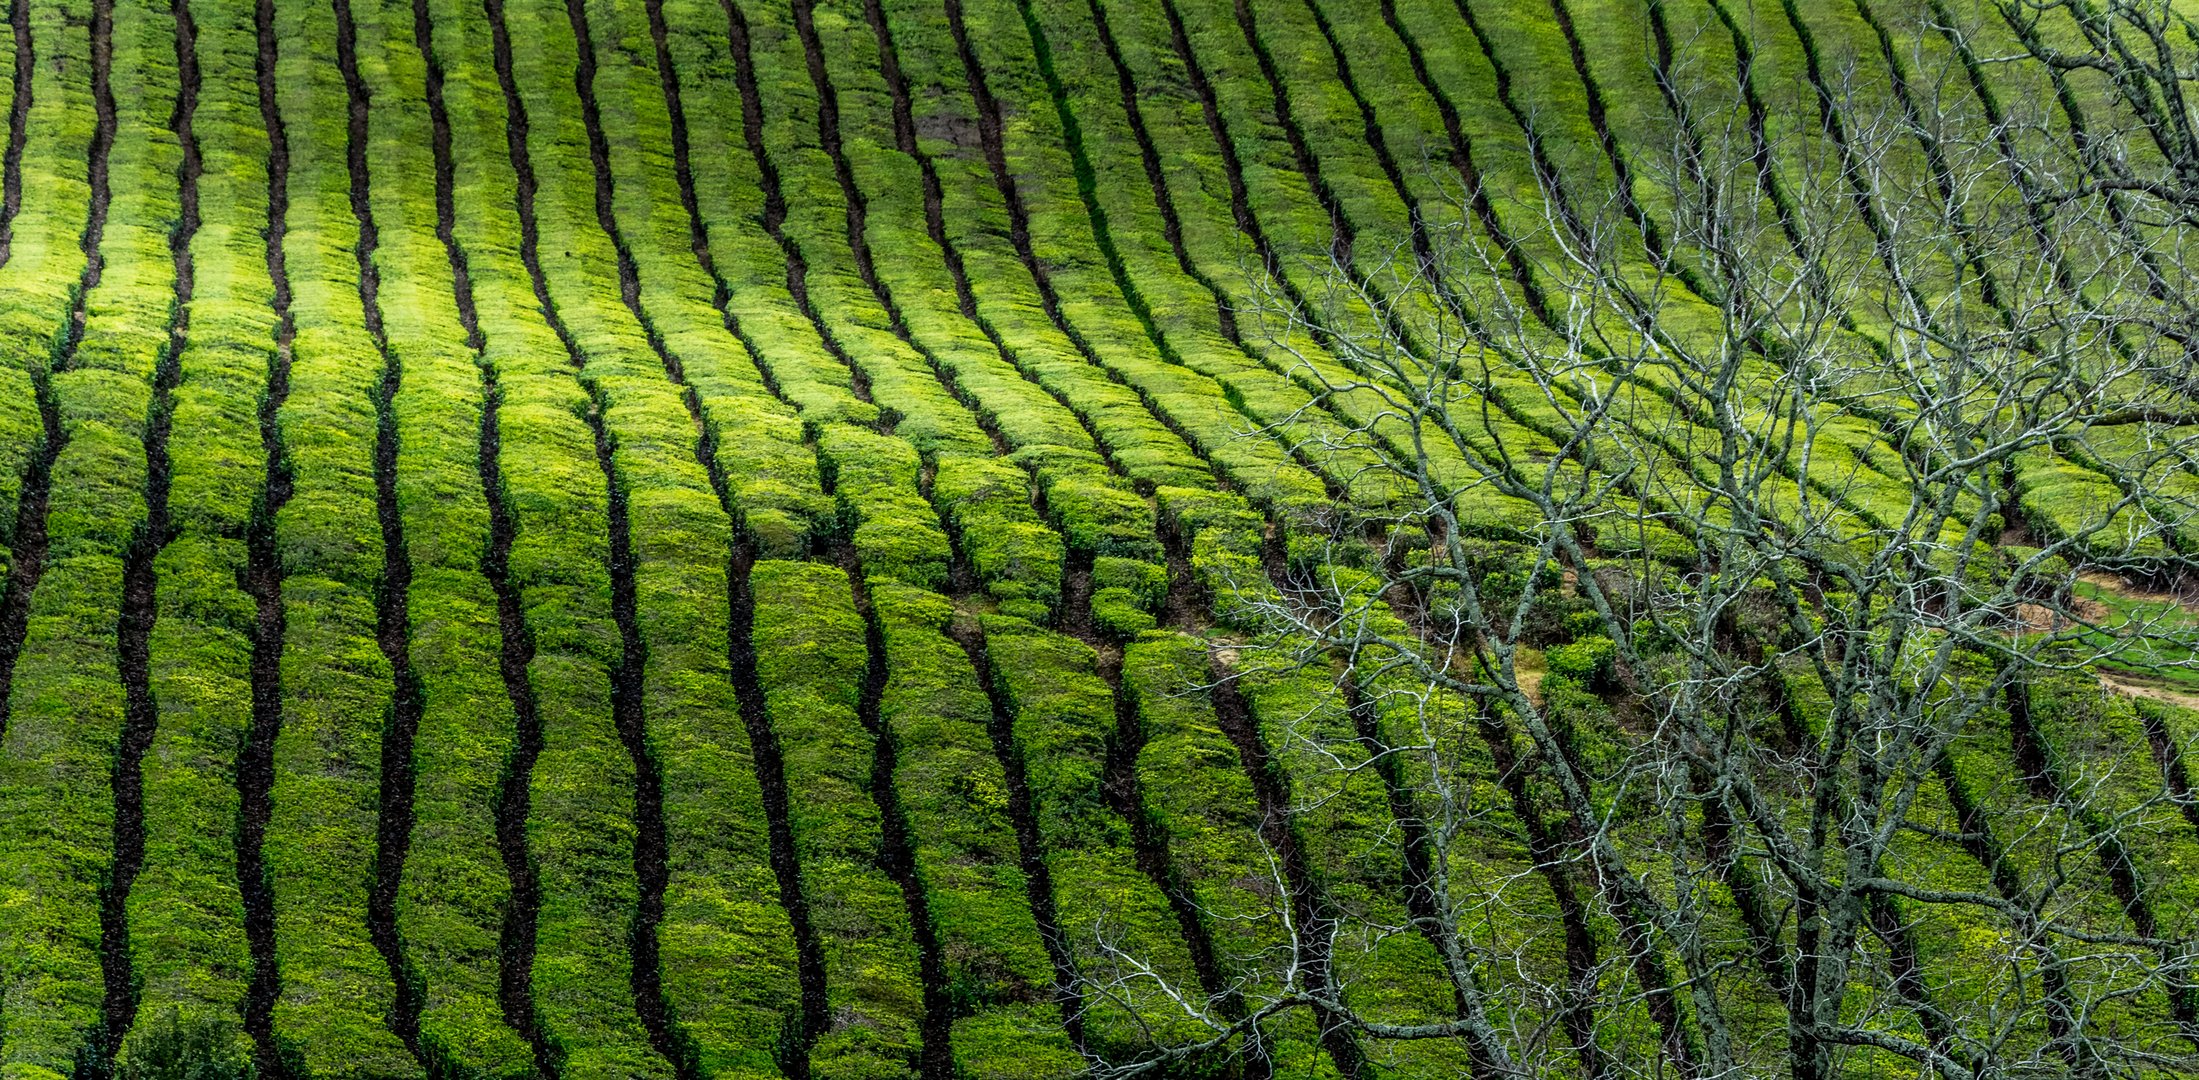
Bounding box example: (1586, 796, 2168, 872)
(1090, 0, 2199, 1080)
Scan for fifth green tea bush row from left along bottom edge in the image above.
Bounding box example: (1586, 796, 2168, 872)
(433, 2, 664, 1076)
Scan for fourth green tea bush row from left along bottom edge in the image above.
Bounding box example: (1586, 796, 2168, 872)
(354, 2, 528, 1076)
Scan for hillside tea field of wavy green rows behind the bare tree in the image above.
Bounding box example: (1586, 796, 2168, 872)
(0, 0, 2199, 1080)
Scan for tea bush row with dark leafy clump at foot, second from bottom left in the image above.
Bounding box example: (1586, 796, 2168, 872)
(130, 4, 272, 1060)
